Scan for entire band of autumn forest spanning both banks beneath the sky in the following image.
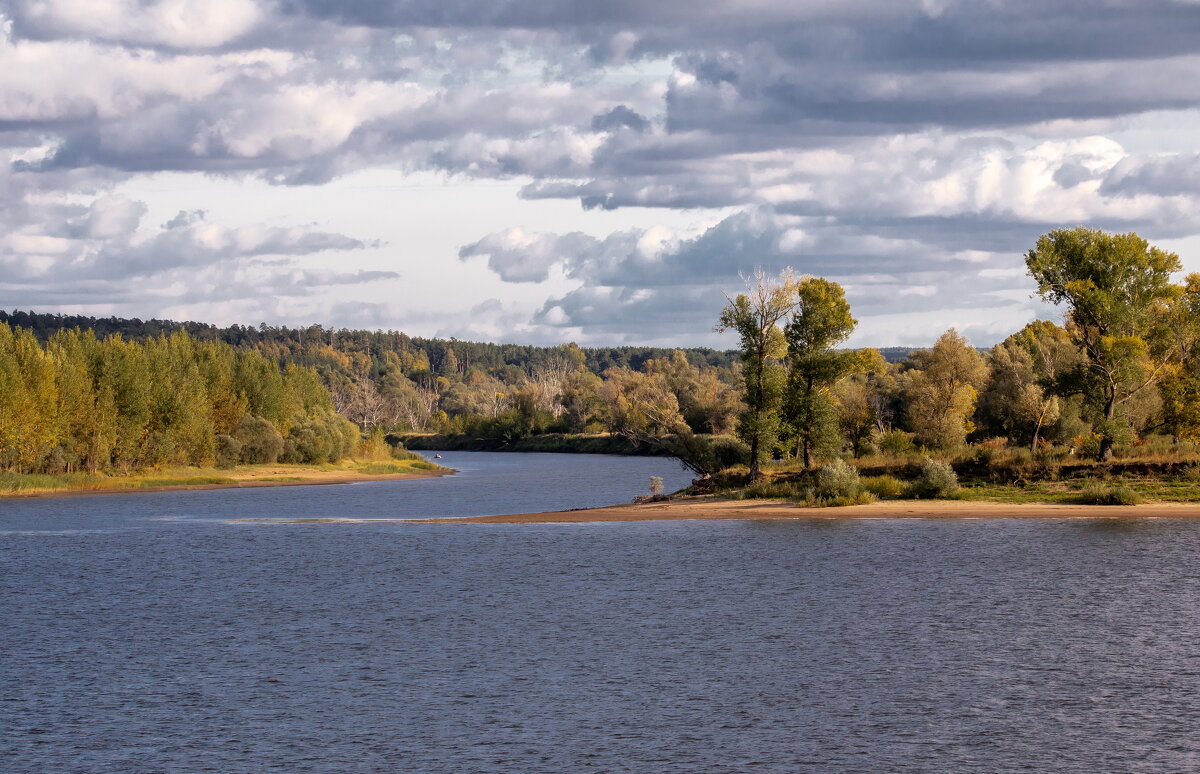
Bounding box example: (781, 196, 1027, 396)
(7, 228, 1200, 489)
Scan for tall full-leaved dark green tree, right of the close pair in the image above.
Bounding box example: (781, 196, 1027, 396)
(784, 277, 860, 468)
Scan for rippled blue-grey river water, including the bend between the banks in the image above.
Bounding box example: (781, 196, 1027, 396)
(0, 454, 1200, 773)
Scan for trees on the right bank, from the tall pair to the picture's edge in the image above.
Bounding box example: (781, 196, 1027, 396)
(720, 228, 1200, 478)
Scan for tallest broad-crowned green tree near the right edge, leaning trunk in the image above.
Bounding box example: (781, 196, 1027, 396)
(1025, 227, 1190, 460)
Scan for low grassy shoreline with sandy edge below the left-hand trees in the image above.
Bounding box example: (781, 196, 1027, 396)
(0, 466, 457, 500)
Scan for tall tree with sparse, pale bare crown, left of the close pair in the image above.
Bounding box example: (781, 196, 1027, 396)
(716, 269, 798, 480)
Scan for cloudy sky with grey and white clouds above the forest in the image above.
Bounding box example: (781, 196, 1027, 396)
(0, 0, 1200, 346)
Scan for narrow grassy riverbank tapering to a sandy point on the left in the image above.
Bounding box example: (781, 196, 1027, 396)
(0, 460, 454, 499)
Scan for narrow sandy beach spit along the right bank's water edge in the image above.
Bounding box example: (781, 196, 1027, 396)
(415, 497, 1200, 524)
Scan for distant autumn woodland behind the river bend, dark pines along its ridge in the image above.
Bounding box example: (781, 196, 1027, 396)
(0, 312, 738, 440)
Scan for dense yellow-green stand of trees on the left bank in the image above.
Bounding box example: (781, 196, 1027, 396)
(0, 324, 360, 473)
